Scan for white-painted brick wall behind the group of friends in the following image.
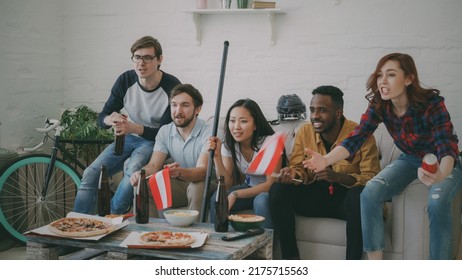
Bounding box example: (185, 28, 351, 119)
(0, 0, 462, 151)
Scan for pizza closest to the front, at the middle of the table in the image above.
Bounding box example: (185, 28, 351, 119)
(140, 231, 196, 247)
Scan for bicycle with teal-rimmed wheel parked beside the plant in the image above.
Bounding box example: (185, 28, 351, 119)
(0, 118, 110, 242)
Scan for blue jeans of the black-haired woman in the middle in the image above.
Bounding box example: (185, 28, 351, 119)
(210, 184, 273, 229)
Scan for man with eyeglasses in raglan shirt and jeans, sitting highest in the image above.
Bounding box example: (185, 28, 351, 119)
(74, 36, 180, 214)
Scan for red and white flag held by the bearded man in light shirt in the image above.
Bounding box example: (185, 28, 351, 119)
(149, 167, 172, 210)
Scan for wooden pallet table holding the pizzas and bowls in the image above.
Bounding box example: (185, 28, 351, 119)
(26, 218, 273, 260)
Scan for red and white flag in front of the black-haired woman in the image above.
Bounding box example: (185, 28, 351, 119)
(247, 133, 285, 175)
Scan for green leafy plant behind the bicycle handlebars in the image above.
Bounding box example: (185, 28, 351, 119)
(61, 105, 114, 165)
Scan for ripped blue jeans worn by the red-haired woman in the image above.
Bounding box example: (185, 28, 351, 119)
(361, 154, 462, 259)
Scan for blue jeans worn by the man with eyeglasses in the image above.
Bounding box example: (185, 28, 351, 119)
(74, 135, 154, 214)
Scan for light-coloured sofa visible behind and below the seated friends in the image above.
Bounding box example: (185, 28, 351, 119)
(273, 120, 462, 260)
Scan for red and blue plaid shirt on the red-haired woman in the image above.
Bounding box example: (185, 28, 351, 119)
(340, 96, 459, 161)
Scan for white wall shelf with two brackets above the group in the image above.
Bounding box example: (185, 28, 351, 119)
(185, 9, 285, 45)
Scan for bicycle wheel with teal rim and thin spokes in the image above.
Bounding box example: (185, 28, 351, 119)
(0, 154, 80, 242)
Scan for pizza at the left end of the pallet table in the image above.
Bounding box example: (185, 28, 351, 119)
(48, 218, 115, 237)
